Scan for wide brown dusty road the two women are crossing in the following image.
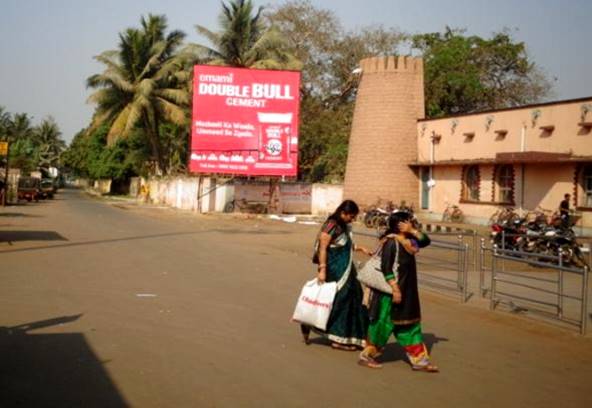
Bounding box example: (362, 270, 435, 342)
(0, 190, 592, 408)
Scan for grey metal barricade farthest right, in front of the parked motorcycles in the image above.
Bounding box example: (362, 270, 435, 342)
(486, 245, 589, 334)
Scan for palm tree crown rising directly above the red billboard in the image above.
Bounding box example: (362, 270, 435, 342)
(195, 0, 301, 69)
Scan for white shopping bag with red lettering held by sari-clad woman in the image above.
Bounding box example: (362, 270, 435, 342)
(292, 279, 337, 330)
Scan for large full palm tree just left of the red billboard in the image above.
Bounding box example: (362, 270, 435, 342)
(87, 14, 192, 173)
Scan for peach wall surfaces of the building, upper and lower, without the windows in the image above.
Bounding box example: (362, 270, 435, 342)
(417, 98, 592, 228)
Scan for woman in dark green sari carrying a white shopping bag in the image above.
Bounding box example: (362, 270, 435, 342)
(300, 200, 371, 351)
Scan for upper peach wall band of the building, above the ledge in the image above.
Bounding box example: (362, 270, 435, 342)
(417, 98, 592, 163)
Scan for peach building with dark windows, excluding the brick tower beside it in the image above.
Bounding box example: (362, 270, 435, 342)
(410, 97, 592, 233)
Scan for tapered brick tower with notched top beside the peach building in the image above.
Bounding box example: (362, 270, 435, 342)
(344, 57, 425, 208)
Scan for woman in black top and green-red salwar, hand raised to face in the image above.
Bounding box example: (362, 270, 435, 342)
(359, 211, 438, 372)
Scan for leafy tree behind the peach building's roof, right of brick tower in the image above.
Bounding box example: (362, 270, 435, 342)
(412, 28, 551, 117)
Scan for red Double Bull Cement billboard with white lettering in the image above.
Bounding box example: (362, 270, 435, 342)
(189, 65, 300, 176)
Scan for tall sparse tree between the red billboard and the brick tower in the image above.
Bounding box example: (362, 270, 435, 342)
(266, 0, 405, 182)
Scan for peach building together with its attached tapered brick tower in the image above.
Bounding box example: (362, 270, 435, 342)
(344, 57, 592, 234)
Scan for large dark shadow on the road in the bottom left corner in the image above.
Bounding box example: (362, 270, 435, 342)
(0, 315, 129, 407)
